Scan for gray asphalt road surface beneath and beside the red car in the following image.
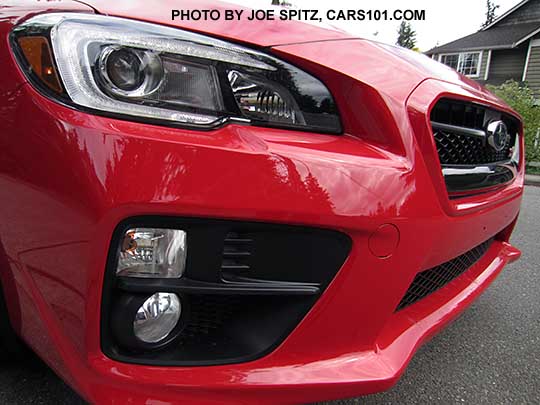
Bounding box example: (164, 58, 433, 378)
(0, 187, 540, 405)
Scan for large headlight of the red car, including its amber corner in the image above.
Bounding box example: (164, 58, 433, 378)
(12, 14, 341, 133)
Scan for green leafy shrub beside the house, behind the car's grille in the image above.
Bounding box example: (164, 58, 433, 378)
(487, 80, 540, 162)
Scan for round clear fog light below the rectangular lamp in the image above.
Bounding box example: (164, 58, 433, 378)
(133, 293, 182, 343)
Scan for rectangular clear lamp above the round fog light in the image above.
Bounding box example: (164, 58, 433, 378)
(116, 228, 187, 278)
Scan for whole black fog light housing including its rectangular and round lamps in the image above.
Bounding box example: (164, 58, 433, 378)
(101, 216, 352, 366)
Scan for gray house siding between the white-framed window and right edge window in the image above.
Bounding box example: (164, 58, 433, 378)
(487, 44, 528, 85)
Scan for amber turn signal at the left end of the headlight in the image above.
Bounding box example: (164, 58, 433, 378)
(18, 36, 62, 93)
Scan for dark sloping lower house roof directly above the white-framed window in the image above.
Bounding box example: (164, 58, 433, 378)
(426, 21, 540, 55)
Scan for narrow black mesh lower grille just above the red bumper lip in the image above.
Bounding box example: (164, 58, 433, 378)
(396, 239, 493, 311)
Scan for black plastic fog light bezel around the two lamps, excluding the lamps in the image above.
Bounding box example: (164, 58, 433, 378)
(100, 215, 352, 367)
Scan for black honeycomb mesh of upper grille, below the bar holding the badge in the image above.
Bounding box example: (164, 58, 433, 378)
(433, 129, 512, 165)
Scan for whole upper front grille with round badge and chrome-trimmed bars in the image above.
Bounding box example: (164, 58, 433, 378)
(430, 99, 520, 194)
